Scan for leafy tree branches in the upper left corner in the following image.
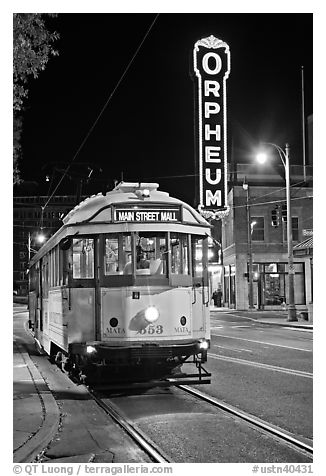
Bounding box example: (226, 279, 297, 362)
(13, 13, 59, 184)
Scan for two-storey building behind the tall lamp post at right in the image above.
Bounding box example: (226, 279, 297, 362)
(222, 164, 313, 310)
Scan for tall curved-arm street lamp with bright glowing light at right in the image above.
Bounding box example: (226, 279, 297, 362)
(257, 142, 298, 322)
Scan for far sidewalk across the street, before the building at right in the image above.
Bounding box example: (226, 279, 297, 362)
(210, 306, 313, 330)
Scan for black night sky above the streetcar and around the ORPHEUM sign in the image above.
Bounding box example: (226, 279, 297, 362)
(17, 13, 313, 203)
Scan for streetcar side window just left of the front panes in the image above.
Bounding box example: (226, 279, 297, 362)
(72, 238, 94, 279)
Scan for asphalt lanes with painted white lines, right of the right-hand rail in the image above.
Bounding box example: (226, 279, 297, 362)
(203, 312, 313, 439)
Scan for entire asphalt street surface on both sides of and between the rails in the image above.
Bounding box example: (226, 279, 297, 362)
(14, 306, 312, 463)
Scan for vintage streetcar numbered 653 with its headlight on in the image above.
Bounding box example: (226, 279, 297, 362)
(29, 182, 211, 384)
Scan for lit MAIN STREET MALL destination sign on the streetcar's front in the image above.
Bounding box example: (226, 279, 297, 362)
(114, 208, 181, 223)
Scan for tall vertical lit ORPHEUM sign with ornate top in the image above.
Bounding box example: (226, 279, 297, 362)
(193, 35, 230, 215)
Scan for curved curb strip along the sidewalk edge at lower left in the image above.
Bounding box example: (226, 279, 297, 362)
(13, 342, 60, 463)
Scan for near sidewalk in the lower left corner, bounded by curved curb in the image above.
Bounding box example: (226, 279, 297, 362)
(13, 309, 60, 463)
